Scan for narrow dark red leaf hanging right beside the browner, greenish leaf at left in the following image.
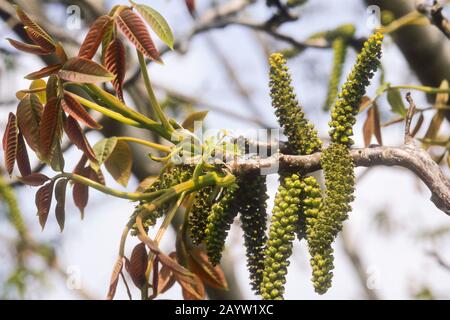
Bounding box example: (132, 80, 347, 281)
(39, 98, 62, 159)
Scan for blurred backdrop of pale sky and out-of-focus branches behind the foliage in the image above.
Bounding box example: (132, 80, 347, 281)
(0, 0, 450, 299)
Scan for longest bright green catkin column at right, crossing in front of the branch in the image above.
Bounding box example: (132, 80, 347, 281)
(307, 33, 383, 294)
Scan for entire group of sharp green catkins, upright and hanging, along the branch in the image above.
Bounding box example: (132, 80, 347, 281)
(130, 33, 383, 299)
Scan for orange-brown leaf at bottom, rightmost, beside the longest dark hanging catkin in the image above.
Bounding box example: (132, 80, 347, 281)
(188, 248, 228, 290)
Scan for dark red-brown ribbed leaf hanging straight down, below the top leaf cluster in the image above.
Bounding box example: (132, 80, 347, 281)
(105, 38, 126, 101)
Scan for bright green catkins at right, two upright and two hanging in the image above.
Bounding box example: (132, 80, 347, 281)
(261, 33, 383, 299)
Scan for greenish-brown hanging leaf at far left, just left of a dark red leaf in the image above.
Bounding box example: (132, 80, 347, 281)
(16, 93, 44, 152)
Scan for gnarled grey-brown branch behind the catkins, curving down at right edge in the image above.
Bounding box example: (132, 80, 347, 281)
(230, 144, 450, 215)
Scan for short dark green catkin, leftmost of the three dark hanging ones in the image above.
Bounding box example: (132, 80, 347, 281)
(189, 187, 214, 245)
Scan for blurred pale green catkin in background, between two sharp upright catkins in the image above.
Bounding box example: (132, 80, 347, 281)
(323, 38, 348, 111)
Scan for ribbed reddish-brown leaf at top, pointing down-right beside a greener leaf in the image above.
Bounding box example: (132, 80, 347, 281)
(116, 9, 162, 63)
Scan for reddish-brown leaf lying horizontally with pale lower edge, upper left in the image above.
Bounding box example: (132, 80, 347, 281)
(59, 58, 114, 83)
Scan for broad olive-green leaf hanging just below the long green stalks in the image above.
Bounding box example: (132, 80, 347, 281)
(105, 141, 133, 187)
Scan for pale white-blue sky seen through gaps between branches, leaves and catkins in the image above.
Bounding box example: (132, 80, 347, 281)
(0, 0, 450, 299)
